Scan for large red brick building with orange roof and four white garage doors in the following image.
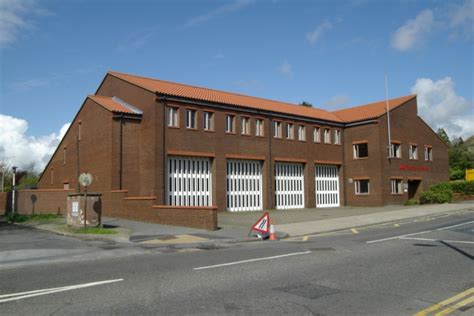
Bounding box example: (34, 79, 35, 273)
(30, 72, 448, 226)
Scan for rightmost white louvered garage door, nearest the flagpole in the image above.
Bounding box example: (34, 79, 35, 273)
(315, 165, 339, 207)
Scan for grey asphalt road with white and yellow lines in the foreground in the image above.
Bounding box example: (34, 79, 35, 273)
(0, 212, 474, 315)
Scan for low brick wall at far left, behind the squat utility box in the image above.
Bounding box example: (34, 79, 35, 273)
(15, 189, 73, 215)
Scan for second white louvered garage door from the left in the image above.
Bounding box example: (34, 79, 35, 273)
(227, 160, 262, 212)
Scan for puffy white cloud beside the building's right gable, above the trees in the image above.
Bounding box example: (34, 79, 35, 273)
(411, 77, 474, 138)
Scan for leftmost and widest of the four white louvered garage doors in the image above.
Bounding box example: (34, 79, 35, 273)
(168, 157, 212, 206)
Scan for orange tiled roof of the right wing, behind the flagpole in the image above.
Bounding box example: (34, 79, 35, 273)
(332, 94, 416, 123)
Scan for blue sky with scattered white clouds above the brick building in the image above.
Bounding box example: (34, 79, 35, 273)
(0, 0, 474, 171)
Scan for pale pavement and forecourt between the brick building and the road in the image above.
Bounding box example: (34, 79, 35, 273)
(10, 201, 474, 246)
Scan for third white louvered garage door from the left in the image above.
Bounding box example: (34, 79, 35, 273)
(275, 162, 304, 210)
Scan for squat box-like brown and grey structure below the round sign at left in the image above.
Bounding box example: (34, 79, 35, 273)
(67, 192, 102, 228)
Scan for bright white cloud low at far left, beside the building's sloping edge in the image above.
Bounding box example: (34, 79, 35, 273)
(0, 114, 70, 172)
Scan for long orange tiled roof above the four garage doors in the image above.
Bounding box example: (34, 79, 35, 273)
(108, 71, 341, 122)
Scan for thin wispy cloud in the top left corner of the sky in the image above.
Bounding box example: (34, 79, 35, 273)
(0, 0, 51, 47)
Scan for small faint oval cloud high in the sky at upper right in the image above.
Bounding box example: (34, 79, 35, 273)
(392, 10, 434, 52)
